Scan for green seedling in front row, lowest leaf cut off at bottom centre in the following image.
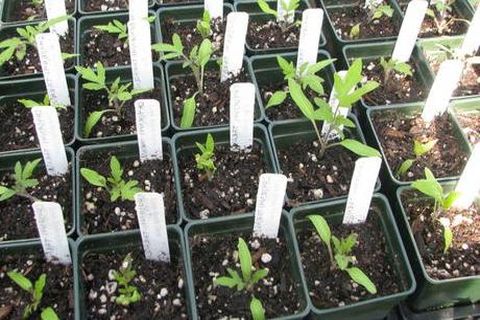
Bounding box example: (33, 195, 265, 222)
(215, 238, 268, 320)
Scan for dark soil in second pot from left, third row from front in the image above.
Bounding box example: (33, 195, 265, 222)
(80, 81, 166, 138)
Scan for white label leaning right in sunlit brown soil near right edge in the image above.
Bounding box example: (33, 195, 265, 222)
(422, 60, 463, 122)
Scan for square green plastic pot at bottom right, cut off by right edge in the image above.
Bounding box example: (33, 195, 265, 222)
(395, 182, 480, 311)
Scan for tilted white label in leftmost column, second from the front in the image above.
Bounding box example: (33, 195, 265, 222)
(32, 106, 68, 176)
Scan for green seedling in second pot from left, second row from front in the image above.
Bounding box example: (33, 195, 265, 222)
(80, 156, 142, 202)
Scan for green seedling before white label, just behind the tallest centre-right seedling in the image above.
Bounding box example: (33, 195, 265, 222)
(265, 56, 336, 109)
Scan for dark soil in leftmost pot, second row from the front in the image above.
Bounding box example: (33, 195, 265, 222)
(0, 164, 73, 243)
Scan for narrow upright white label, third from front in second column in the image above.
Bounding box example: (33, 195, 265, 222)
(128, 19, 154, 90)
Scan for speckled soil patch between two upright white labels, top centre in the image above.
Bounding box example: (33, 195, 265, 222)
(247, 20, 300, 49)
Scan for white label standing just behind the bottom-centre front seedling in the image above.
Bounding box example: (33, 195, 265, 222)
(253, 173, 287, 238)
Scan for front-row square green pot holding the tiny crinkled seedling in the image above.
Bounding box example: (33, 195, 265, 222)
(74, 226, 196, 320)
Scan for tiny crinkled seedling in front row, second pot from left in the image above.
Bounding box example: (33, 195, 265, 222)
(113, 253, 142, 307)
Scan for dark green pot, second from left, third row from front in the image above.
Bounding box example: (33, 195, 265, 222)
(75, 63, 170, 144)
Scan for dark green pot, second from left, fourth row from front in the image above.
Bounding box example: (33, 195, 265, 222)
(76, 10, 159, 67)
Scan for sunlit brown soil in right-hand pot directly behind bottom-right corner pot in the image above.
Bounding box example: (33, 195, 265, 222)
(372, 110, 468, 181)
